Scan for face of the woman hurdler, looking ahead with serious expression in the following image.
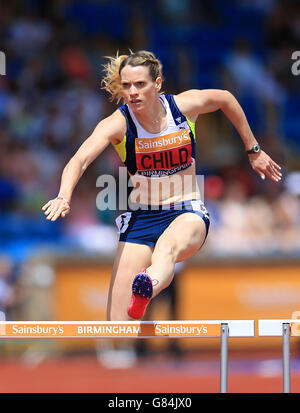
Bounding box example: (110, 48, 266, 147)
(120, 65, 162, 111)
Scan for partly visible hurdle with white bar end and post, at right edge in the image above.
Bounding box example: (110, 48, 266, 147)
(258, 319, 300, 393)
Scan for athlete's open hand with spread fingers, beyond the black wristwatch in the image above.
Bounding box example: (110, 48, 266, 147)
(248, 150, 282, 182)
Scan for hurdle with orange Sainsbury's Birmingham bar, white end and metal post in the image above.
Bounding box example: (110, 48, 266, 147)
(0, 320, 255, 393)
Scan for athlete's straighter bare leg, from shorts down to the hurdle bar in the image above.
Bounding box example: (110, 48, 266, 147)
(107, 242, 153, 320)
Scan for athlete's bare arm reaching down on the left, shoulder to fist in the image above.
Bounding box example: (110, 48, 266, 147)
(42, 110, 126, 221)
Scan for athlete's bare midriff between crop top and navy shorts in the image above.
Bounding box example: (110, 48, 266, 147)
(129, 163, 201, 205)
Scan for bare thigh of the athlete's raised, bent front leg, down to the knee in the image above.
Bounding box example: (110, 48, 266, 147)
(155, 212, 206, 262)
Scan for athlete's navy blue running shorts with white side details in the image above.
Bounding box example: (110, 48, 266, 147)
(116, 199, 209, 247)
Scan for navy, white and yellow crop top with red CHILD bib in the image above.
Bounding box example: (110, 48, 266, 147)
(114, 94, 195, 178)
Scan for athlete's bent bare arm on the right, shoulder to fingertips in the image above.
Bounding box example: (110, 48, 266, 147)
(174, 89, 281, 182)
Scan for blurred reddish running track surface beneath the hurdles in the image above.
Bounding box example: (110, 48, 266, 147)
(0, 354, 300, 393)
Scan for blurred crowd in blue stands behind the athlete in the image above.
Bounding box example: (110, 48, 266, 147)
(0, 0, 300, 280)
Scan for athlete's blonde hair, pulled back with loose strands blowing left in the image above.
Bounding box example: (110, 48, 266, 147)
(101, 50, 162, 103)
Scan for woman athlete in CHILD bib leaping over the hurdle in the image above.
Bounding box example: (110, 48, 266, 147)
(42, 51, 281, 320)
